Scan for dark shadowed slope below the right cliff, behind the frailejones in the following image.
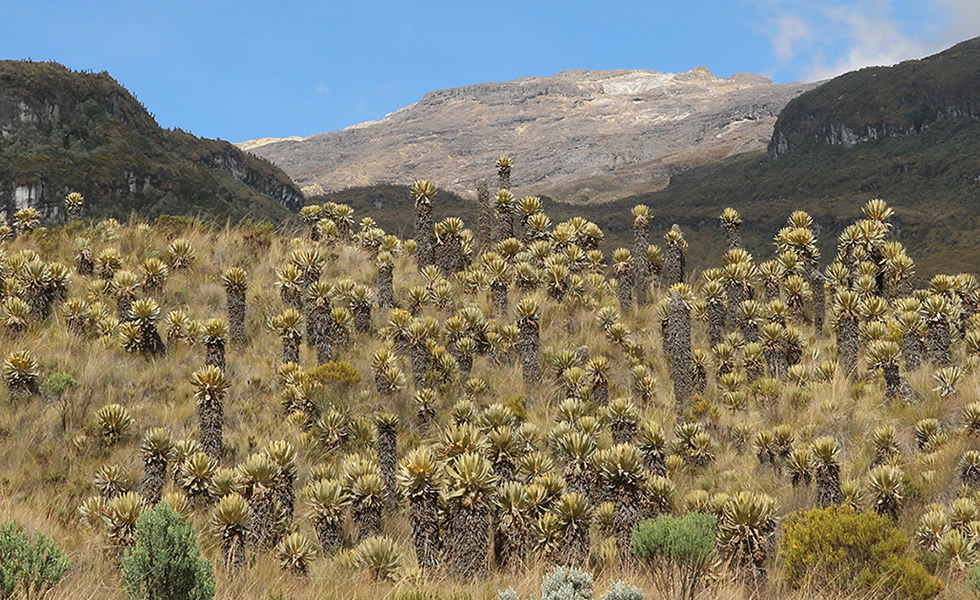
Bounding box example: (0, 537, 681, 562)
(311, 112, 980, 279)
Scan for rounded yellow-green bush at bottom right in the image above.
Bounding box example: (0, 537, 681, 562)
(780, 507, 943, 600)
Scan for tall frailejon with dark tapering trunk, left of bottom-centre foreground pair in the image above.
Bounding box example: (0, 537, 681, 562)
(398, 446, 443, 575)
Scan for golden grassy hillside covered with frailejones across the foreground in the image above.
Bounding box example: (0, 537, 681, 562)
(0, 195, 980, 600)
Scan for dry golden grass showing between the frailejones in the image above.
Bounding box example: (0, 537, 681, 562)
(0, 213, 980, 600)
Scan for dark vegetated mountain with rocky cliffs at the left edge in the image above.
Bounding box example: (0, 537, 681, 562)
(0, 60, 304, 221)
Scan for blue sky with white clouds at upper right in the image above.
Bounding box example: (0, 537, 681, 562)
(0, 0, 980, 141)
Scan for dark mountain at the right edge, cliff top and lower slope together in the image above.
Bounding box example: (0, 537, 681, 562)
(608, 38, 980, 277)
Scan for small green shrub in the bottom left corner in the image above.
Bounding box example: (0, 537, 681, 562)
(0, 522, 69, 598)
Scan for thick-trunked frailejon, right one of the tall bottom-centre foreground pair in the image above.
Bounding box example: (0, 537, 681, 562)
(443, 452, 497, 580)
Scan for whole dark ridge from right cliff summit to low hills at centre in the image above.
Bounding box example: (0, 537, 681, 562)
(315, 40, 980, 280)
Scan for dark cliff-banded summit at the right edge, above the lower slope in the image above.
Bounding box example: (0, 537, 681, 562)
(769, 38, 980, 157)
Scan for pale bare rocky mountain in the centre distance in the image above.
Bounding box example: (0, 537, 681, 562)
(240, 67, 811, 195)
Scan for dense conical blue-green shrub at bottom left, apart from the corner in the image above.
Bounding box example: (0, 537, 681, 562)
(122, 502, 214, 600)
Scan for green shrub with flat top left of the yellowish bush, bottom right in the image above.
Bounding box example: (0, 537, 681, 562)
(633, 513, 718, 599)
